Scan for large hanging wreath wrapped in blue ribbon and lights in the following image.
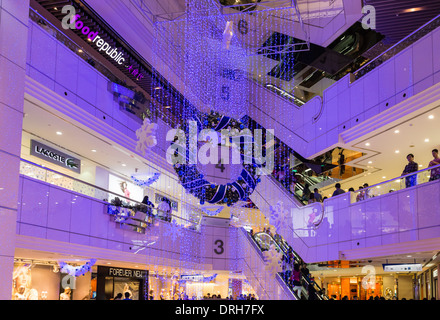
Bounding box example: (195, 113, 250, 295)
(171, 111, 261, 206)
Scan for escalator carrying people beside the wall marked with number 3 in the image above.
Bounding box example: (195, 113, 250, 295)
(250, 232, 328, 300)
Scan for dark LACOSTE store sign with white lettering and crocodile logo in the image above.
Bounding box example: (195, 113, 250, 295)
(30, 140, 81, 173)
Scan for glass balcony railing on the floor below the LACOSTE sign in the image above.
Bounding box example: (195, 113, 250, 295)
(20, 159, 201, 231)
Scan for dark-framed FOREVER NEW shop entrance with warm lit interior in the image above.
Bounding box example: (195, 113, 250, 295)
(96, 266, 148, 300)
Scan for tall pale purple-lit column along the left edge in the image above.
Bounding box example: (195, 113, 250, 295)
(0, 0, 29, 300)
